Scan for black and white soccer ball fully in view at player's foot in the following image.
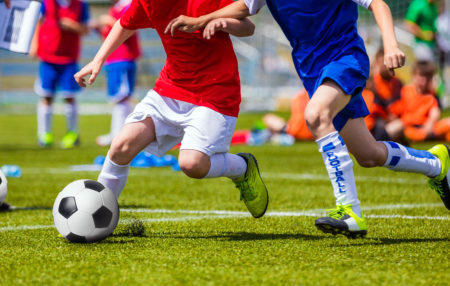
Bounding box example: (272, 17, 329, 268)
(53, 180, 119, 242)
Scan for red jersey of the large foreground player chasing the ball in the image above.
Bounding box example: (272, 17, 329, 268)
(120, 0, 241, 117)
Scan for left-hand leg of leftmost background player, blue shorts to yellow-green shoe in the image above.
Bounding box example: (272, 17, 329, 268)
(34, 62, 58, 147)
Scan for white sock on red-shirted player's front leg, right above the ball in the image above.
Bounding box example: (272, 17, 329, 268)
(98, 155, 130, 198)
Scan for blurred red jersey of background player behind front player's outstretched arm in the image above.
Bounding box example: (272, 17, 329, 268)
(102, 0, 141, 64)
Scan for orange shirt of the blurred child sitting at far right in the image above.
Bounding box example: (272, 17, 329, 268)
(399, 84, 439, 126)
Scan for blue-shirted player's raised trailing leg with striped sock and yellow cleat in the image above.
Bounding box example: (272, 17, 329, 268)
(341, 118, 450, 209)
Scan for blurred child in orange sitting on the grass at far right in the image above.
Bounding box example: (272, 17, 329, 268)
(396, 61, 450, 142)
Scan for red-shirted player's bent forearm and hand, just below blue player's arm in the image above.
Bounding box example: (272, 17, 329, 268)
(203, 18, 255, 40)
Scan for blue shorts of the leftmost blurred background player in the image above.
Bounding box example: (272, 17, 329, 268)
(34, 62, 81, 98)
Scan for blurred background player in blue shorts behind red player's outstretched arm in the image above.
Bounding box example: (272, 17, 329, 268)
(90, 0, 141, 146)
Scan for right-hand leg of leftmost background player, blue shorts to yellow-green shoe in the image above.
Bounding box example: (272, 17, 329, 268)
(59, 63, 80, 148)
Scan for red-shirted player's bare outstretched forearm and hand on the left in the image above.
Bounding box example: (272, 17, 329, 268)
(74, 21, 136, 87)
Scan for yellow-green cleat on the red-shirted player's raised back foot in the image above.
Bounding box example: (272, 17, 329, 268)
(233, 153, 269, 218)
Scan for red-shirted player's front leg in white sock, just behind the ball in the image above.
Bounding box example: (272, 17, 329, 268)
(98, 117, 155, 198)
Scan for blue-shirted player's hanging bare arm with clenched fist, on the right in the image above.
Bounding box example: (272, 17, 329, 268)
(368, 0, 405, 72)
